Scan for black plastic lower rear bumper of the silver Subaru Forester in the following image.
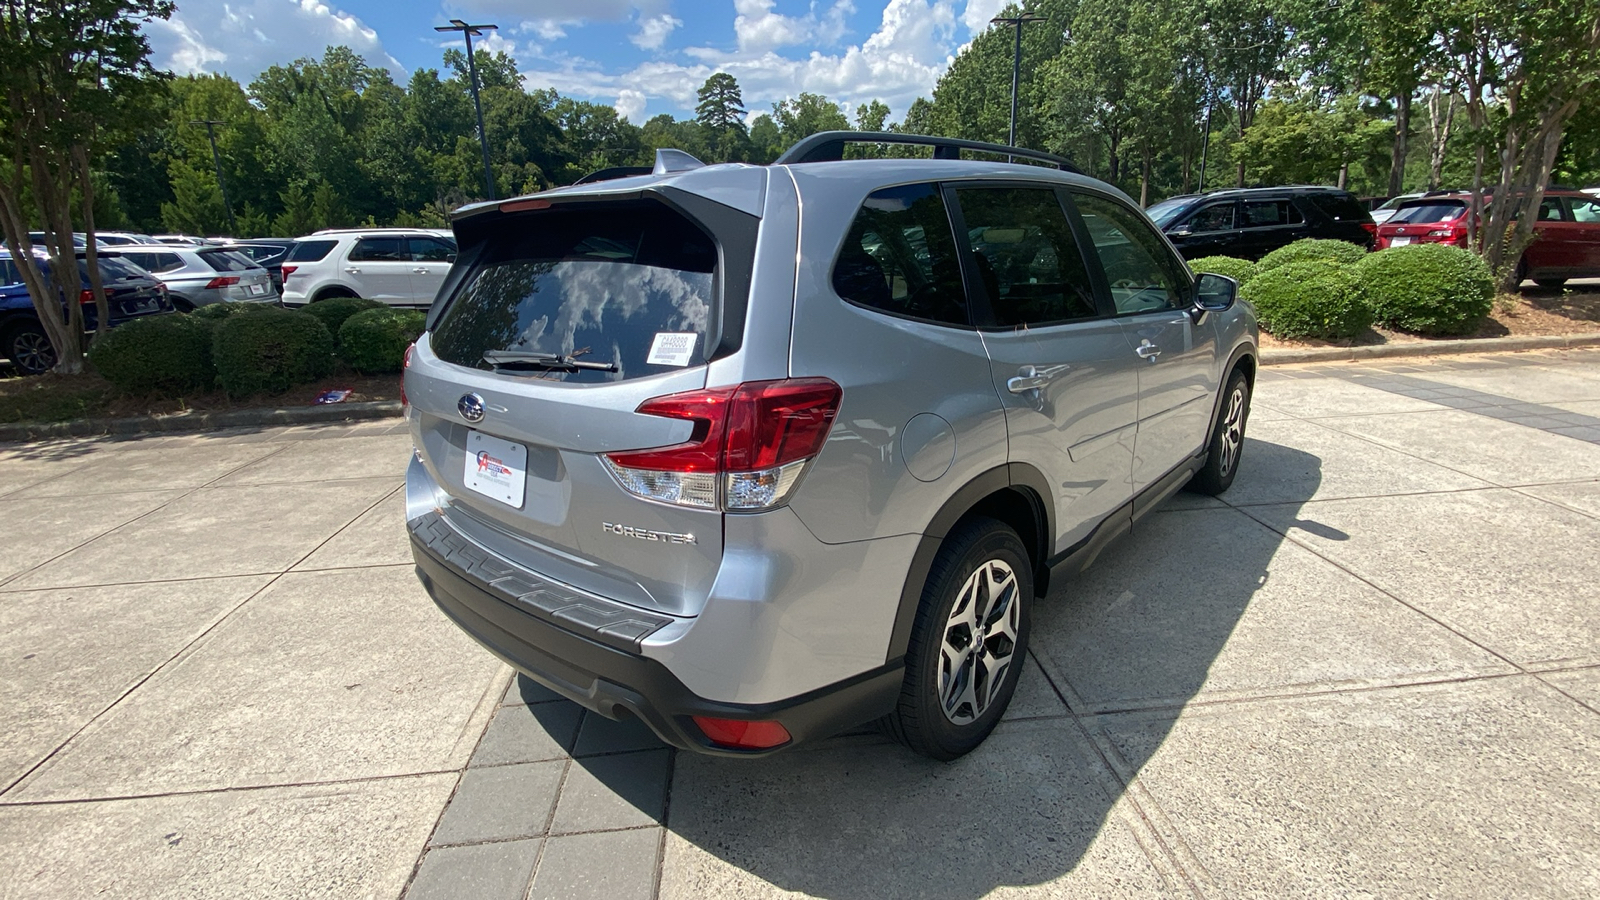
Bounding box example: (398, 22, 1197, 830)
(411, 516, 904, 756)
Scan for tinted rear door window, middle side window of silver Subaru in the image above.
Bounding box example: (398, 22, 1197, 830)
(955, 187, 1098, 327)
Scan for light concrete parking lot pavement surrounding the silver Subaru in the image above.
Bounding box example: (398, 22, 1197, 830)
(0, 351, 1600, 900)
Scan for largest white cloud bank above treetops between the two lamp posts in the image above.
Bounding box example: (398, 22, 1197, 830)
(523, 0, 957, 122)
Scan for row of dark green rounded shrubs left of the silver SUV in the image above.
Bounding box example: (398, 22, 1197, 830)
(90, 298, 426, 397)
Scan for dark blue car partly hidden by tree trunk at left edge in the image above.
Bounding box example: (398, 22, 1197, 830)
(0, 250, 173, 375)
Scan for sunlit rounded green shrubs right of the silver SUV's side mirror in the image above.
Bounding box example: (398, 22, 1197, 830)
(1189, 239, 1494, 338)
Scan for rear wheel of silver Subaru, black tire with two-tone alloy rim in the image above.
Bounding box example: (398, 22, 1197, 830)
(882, 517, 1034, 761)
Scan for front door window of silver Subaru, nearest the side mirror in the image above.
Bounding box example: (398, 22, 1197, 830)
(1072, 194, 1189, 315)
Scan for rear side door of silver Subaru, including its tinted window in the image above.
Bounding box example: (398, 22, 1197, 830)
(952, 184, 1139, 552)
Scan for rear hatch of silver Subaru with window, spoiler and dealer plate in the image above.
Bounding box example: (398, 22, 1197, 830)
(405, 184, 760, 615)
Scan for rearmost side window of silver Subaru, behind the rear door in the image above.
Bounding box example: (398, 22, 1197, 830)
(834, 184, 970, 325)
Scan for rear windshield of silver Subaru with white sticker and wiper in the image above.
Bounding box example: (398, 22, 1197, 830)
(432, 202, 717, 383)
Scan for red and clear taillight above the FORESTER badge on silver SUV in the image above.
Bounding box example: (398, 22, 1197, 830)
(605, 378, 843, 511)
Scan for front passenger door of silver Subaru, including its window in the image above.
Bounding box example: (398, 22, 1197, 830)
(1072, 192, 1218, 492)
